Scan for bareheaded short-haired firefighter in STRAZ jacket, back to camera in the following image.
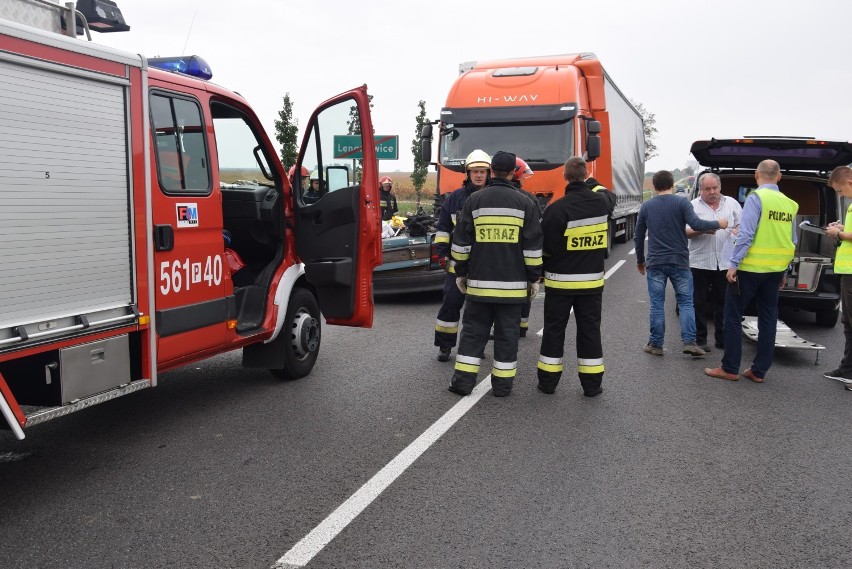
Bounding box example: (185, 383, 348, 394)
(537, 156, 610, 397)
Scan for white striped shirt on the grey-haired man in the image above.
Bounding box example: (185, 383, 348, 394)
(689, 196, 743, 271)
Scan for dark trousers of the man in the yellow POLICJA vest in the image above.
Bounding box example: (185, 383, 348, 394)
(722, 271, 784, 378)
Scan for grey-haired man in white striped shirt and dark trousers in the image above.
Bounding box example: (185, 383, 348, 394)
(686, 172, 743, 352)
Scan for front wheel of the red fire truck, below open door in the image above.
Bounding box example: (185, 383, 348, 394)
(269, 287, 322, 379)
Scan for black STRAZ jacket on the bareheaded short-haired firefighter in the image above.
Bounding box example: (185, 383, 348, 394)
(541, 182, 610, 295)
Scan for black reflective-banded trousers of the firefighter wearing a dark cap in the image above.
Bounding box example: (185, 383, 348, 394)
(450, 301, 523, 397)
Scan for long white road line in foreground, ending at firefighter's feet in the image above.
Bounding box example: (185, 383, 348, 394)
(272, 375, 491, 569)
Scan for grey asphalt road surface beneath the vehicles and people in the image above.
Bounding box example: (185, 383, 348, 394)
(0, 245, 852, 569)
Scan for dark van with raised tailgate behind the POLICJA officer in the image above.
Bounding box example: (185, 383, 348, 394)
(691, 137, 852, 326)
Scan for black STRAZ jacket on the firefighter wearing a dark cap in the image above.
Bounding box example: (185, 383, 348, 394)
(450, 179, 542, 304)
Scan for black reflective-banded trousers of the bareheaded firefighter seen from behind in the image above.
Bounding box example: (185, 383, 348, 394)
(537, 293, 604, 397)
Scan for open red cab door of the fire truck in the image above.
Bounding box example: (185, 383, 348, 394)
(293, 86, 382, 327)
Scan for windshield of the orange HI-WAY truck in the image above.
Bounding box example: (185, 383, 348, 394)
(439, 119, 574, 167)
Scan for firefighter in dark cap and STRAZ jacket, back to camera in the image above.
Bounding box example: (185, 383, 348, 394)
(449, 151, 542, 397)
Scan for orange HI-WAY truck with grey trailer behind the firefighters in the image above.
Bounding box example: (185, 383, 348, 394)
(421, 53, 645, 251)
